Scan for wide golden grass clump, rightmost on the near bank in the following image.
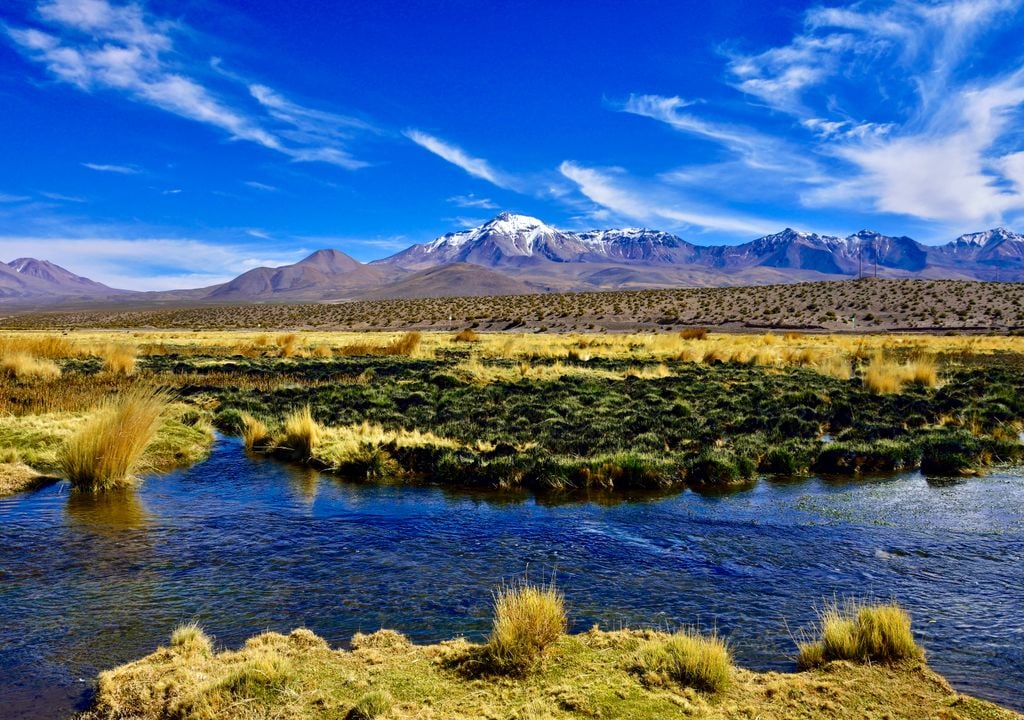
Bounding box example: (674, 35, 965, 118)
(798, 600, 924, 669)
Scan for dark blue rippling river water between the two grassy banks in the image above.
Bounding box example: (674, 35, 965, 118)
(0, 439, 1024, 718)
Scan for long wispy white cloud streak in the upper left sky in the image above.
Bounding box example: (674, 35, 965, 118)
(6, 0, 370, 170)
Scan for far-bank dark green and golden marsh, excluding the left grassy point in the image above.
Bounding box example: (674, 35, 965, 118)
(0, 329, 1024, 491)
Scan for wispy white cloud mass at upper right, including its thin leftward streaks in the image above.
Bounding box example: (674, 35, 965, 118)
(616, 0, 1024, 231)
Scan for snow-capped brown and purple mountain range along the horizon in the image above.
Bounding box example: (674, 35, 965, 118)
(0, 212, 1024, 305)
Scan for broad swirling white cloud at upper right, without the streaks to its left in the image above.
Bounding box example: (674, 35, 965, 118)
(716, 0, 1024, 225)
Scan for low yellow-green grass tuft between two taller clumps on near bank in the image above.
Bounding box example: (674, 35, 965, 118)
(636, 630, 732, 692)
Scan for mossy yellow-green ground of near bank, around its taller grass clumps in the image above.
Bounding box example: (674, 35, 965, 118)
(81, 629, 1022, 720)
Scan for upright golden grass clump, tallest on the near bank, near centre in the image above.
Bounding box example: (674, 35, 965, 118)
(486, 580, 567, 674)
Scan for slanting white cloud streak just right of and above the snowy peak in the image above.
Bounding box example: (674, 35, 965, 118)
(559, 161, 773, 236)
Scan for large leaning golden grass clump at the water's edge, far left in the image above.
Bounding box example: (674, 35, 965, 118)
(57, 387, 169, 491)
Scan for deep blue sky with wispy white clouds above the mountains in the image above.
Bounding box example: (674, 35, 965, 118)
(0, 0, 1024, 289)
